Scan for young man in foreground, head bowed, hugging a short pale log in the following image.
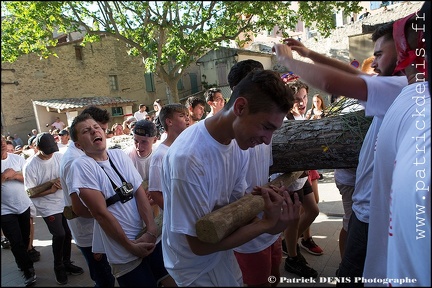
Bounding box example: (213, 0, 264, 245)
(162, 70, 300, 287)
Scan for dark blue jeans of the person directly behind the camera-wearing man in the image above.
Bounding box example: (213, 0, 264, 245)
(77, 245, 115, 287)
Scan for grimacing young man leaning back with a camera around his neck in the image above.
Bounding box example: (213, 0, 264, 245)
(69, 114, 159, 287)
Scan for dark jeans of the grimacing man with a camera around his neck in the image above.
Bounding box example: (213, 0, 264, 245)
(117, 242, 168, 287)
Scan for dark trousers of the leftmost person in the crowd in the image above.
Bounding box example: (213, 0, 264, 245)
(1, 207, 33, 271)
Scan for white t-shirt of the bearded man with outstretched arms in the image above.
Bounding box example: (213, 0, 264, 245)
(352, 76, 408, 223)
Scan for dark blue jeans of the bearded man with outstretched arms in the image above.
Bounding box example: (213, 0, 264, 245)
(336, 211, 369, 287)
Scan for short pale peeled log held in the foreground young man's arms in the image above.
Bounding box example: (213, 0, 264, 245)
(195, 171, 303, 244)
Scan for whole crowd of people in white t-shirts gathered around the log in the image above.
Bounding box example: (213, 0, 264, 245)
(1, 2, 431, 287)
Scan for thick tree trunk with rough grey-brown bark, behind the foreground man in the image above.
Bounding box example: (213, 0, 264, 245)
(270, 111, 372, 174)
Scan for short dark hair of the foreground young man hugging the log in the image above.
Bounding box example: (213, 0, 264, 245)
(223, 70, 294, 114)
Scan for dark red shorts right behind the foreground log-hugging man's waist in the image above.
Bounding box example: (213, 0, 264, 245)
(234, 237, 282, 285)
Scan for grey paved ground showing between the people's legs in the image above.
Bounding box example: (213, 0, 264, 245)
(1, 170, 343, 287)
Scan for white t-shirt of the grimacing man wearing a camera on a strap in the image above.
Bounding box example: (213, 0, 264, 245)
(70, 149, 143, 264)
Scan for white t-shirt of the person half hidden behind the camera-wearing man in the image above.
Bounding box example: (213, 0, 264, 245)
(60, 142, 94, 247)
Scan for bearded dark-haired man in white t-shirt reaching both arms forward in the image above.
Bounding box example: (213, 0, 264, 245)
(275, 16, 407, 286)
